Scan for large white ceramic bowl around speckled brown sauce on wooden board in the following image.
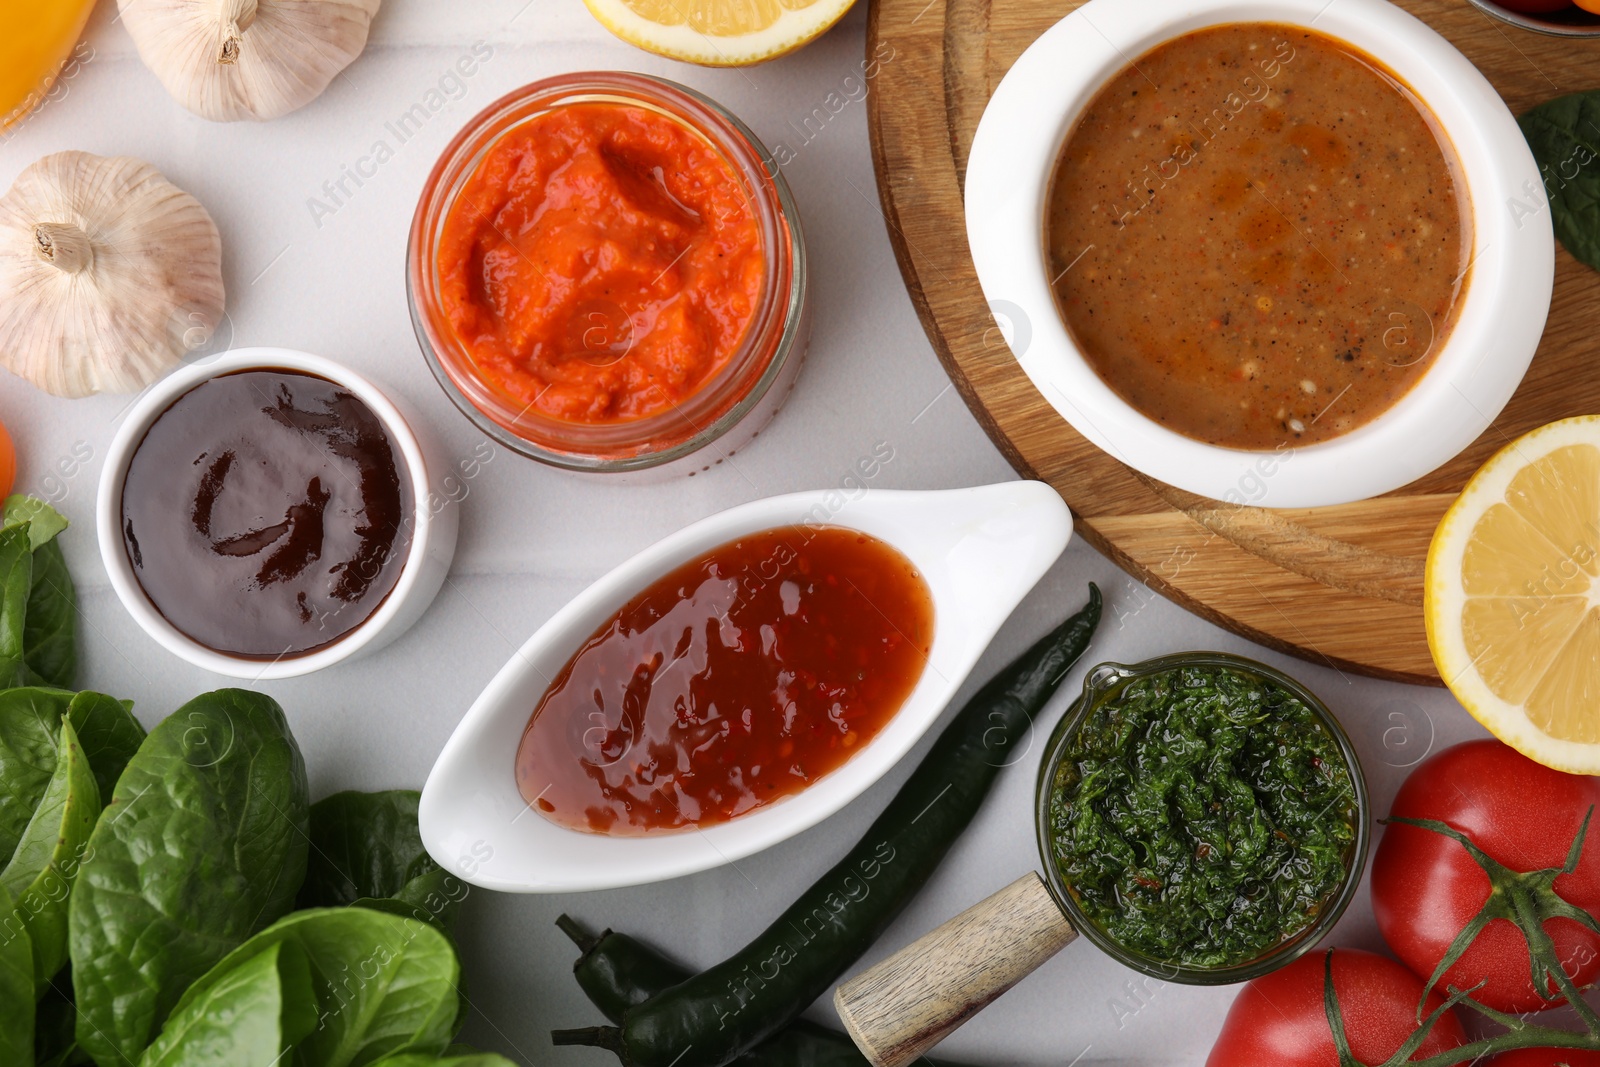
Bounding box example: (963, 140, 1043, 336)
(966, 0, 1555, 507)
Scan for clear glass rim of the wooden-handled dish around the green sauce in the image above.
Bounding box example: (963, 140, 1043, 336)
(1034, 651, 1371, 985)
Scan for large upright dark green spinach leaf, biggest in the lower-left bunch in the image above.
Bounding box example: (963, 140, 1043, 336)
(67, 689, 307, 1067)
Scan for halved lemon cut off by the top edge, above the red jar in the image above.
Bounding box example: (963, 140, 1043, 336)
(584, 0, 856, 67)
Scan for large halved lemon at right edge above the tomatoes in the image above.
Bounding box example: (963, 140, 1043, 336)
(1424, 416, 1600, 774)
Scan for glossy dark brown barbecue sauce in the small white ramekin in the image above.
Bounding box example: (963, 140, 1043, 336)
(120, 370, 414, 659)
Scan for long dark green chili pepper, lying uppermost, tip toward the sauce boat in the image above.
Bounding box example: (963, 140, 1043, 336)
(550, 584, 1101, 1067)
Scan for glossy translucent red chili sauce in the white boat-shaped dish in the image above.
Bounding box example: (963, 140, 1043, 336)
(517, 526, 934, 837)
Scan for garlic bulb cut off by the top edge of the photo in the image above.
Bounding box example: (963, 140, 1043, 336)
(117, 0, 381, 122)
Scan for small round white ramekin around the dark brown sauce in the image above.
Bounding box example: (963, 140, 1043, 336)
(94, 349, 461, 681)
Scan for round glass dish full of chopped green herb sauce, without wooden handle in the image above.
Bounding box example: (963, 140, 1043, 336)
(1038, 653, 1370, 985)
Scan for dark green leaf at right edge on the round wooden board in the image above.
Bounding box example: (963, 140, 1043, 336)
(1517, 90, 1600, 269)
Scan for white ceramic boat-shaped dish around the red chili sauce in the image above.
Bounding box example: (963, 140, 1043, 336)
(418, 482, 1072, 893)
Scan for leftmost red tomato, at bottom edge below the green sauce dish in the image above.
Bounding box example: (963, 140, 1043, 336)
(1205, 949, 1465, 1067)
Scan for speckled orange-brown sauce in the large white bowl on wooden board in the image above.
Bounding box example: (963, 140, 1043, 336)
(1045, 22, 1472, 450)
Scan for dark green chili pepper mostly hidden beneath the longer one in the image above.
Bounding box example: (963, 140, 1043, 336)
(555, 915, 962, 1067)
